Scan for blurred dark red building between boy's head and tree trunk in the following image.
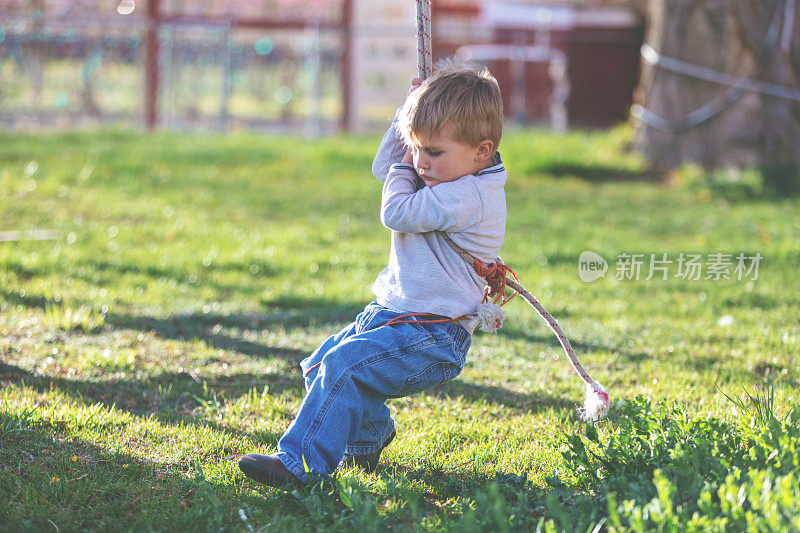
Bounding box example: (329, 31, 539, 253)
(434, 0, 644, 127)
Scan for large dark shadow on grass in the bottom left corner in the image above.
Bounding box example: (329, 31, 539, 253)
(0, 420, 266, 531)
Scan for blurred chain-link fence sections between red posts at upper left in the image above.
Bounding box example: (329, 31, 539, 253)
(0, 4, 350, 135)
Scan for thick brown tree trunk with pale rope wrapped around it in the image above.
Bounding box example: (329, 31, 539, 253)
(633, 0, 800, 190)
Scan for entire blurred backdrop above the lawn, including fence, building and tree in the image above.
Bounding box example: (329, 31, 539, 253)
(0, 0, 800, 183)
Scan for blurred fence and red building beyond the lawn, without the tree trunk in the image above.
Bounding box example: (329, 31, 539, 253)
(0, 0, 644, 135)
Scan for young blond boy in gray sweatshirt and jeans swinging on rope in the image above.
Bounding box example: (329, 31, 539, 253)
(239, 61, 506, 486)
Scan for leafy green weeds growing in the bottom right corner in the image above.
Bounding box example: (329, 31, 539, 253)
(545, 386, 800, 532)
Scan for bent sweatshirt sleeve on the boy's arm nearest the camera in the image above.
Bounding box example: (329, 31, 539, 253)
(381, 163, 483, 233)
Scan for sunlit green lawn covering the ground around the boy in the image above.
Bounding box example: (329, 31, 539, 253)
(0, 129, 800, 531)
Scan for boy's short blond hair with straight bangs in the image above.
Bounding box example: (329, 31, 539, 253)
(398, 59, 503, 155)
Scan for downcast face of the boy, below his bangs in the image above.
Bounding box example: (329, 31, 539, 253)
(411, 129, 492, 187)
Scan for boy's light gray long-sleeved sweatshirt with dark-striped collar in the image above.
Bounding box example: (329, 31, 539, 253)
(372, 117, 506, 318)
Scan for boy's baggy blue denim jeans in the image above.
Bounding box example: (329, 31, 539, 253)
(277, 302, 471, 482)
